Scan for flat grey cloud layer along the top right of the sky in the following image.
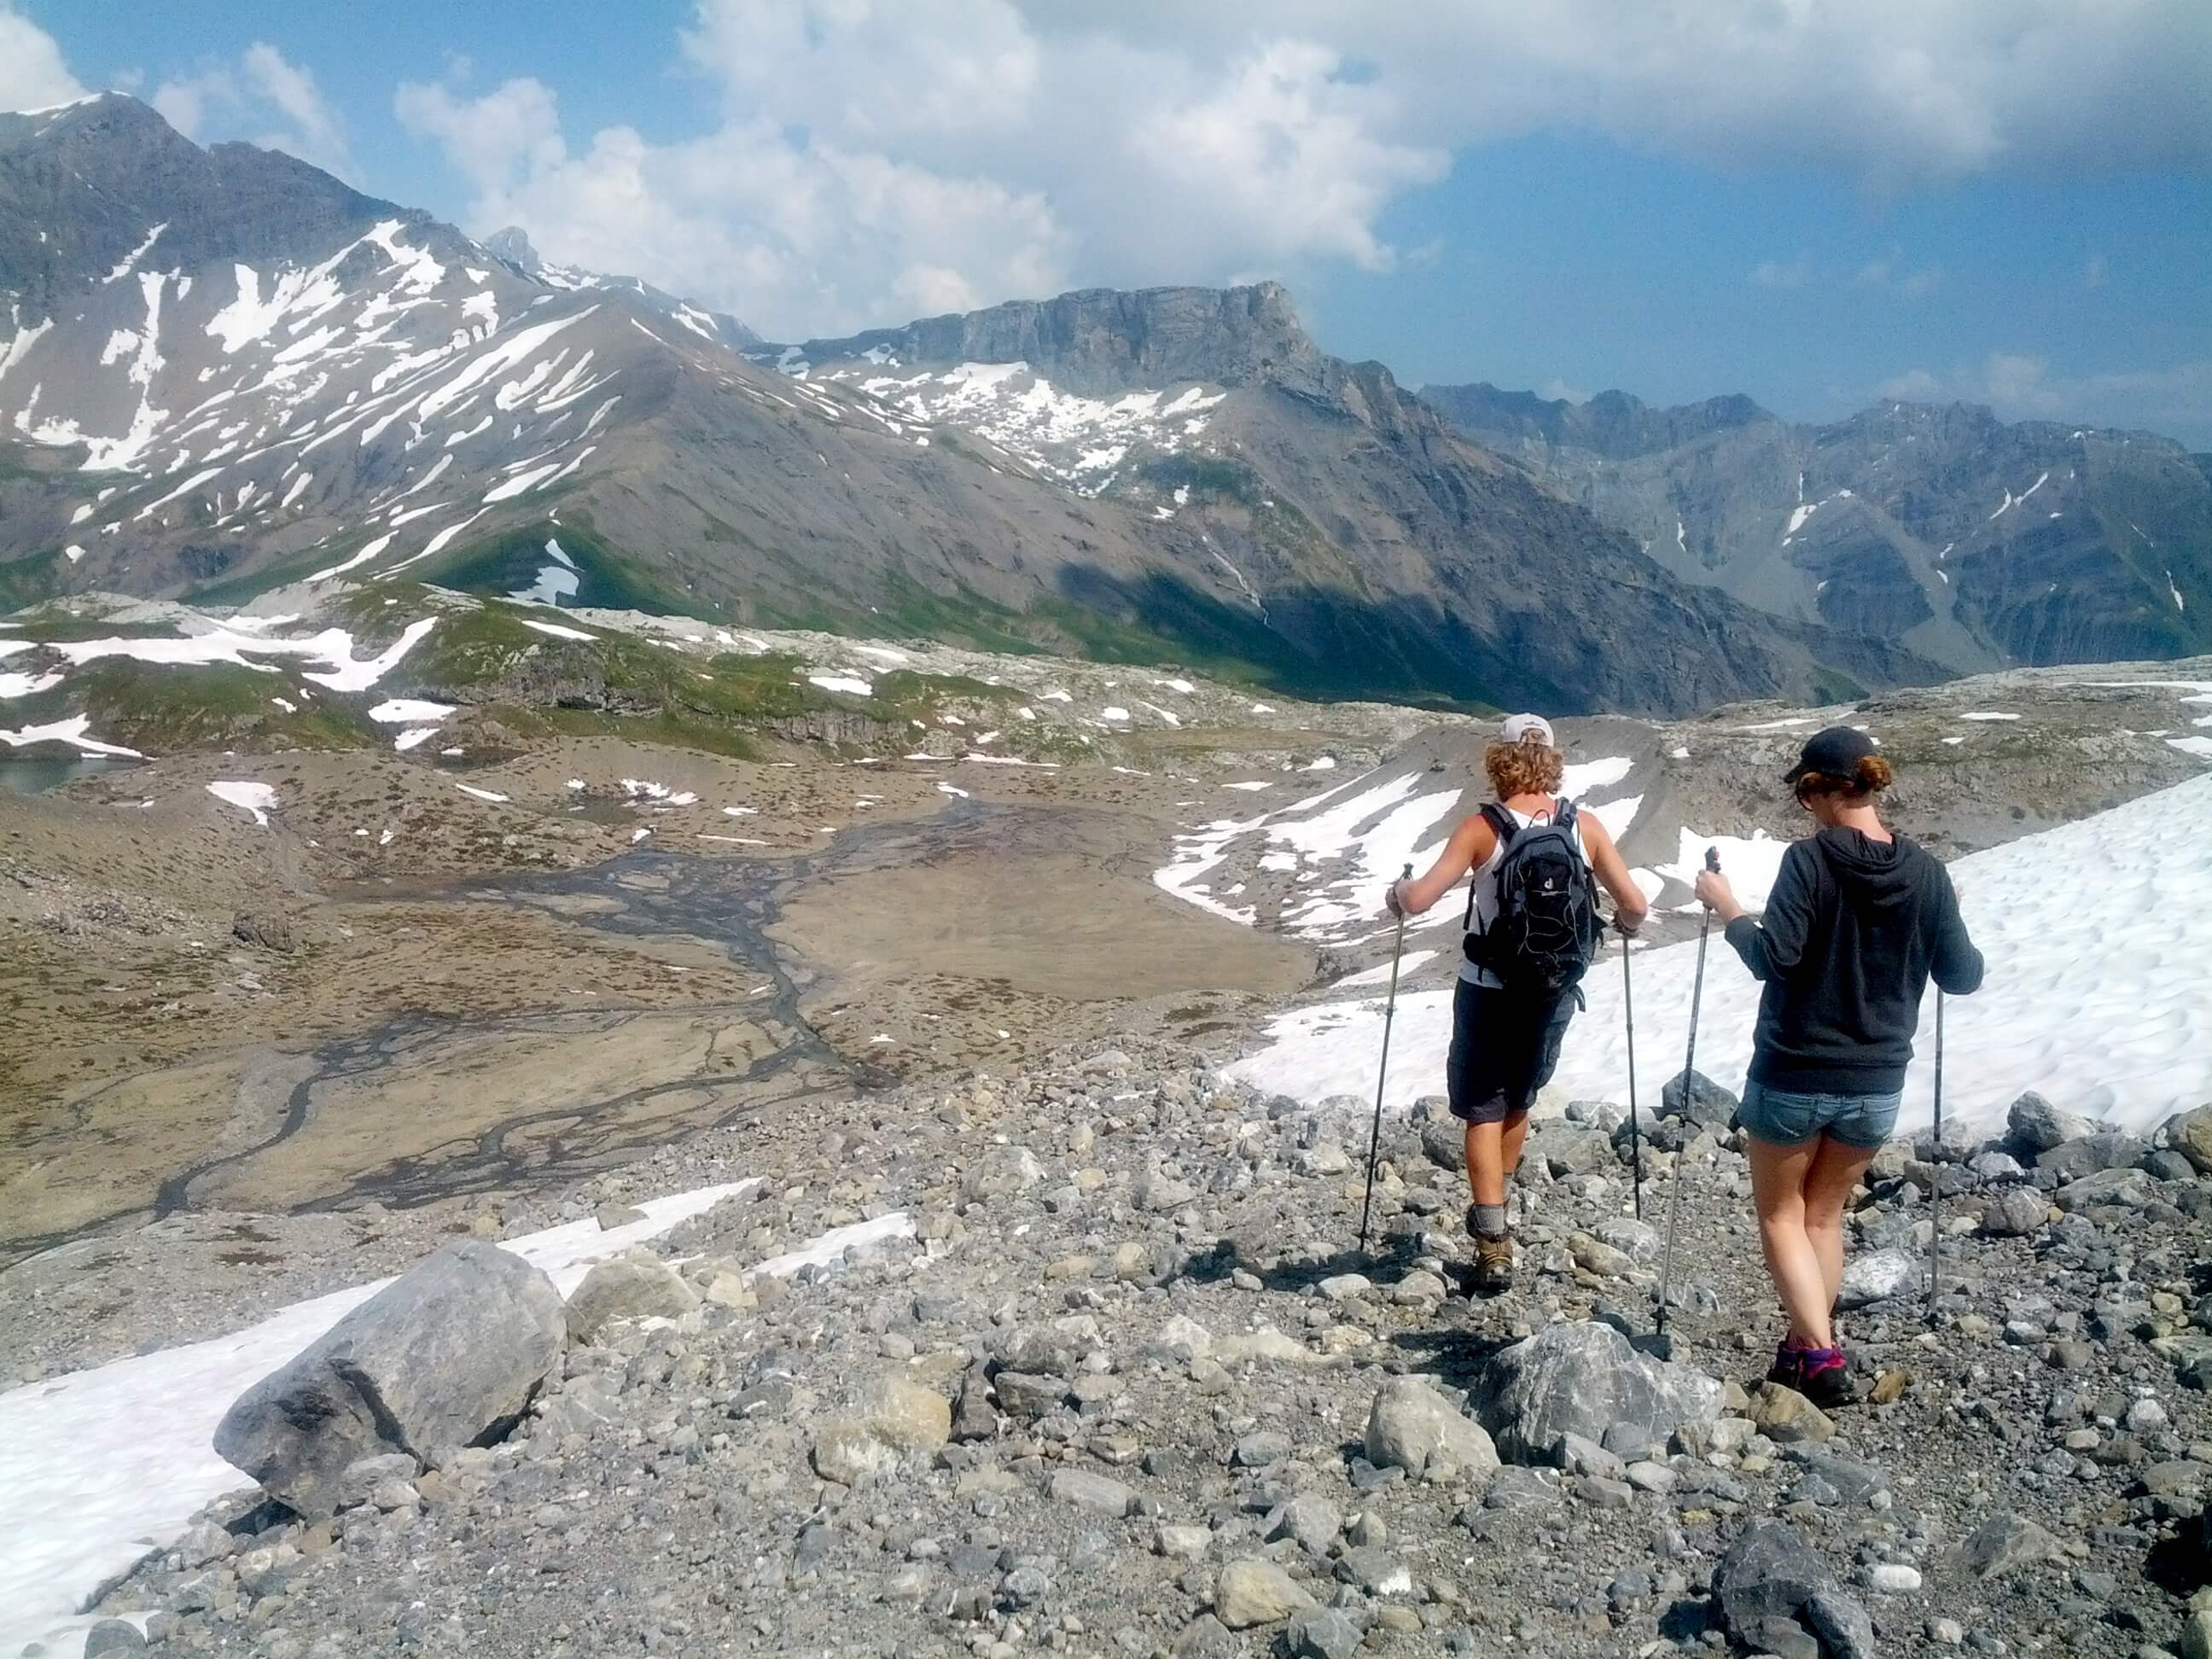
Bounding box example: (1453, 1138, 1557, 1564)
(1057, 0, 2212, 188)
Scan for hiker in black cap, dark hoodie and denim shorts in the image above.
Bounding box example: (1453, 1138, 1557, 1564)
(1697, 725, 1982, 1405)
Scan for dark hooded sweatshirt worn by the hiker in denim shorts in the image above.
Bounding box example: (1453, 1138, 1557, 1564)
(1727, 830, 1982, 1095)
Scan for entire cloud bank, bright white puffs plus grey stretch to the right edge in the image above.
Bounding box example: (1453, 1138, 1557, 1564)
(396, 0, 2212, 334)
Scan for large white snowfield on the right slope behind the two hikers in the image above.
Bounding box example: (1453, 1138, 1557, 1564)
(1230, 777, 2212, 1135)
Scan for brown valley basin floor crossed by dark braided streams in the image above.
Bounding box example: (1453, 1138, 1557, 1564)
(0, 743, 1314, 1252)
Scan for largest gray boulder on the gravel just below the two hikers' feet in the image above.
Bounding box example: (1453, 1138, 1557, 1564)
(1466, 1320, 1721, 1462)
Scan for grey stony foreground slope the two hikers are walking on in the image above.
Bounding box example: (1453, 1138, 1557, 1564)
(51, 1046, 2212, 1659)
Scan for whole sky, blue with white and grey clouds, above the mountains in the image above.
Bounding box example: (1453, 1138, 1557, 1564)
(17, 0, 2212, 449)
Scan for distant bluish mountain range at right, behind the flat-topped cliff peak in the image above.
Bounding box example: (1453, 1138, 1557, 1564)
(1423, 385, 2212, 672)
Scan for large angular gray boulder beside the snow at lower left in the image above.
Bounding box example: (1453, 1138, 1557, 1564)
(214, 1239, 567, 1520)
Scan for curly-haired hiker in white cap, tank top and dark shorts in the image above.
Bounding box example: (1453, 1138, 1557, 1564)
(1387, 714, 1650, 1294)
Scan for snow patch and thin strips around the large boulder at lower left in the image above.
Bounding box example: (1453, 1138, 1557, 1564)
(0, 1179, 913, 1655)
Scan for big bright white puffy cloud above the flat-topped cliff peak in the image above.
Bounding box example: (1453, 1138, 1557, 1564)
(393, 14, 1449, 339)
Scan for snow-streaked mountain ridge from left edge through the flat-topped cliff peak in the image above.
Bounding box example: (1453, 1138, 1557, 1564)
(0, 93, 1936, 710)
